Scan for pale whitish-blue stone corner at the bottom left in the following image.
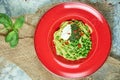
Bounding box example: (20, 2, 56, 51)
(0, 57, 32, 80)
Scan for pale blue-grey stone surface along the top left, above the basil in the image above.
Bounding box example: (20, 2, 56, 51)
(0, 0, 70, 16)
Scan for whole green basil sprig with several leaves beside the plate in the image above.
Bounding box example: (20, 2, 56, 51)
(0, 13, 25, 48)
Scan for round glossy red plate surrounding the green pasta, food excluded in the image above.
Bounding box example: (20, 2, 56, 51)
(34, 2, 111, 78)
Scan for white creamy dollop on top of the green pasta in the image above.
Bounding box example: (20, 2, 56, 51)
(61, 24, 71, 40)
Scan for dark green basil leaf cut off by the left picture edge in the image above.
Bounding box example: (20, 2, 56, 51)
(0, 13, 12, 29)
